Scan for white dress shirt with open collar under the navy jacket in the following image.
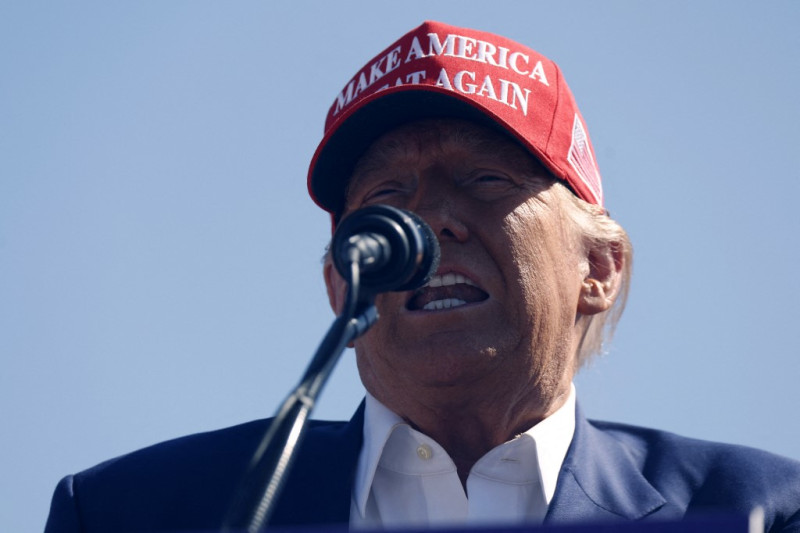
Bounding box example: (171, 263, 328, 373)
(350, 386, 575, 528)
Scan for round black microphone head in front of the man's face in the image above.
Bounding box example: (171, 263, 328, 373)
(331, 205, 441, 294)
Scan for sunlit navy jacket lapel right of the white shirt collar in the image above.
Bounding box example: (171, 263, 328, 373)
(545, 407, 666, 523)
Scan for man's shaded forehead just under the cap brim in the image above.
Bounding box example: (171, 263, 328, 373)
(346, 119, 550, 192)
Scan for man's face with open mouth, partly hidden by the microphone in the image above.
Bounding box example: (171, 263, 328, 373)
(328, 120, 588, 414)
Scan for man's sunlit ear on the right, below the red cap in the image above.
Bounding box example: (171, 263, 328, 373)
(578, 242, 625, 315)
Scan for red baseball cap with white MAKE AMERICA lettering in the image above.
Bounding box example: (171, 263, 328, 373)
(308, 21, 603, 216)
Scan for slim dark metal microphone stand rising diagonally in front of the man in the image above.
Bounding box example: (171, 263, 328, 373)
(222, 258, 378, 533)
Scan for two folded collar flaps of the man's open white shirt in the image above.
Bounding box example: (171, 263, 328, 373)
(353, 385, 575, 516)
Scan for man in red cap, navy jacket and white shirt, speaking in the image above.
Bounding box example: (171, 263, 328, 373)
(47, 22, 800, 532)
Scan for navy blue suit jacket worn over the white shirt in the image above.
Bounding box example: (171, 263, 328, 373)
(46, 406, 800, 533)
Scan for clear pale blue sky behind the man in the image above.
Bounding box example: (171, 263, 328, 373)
(0, 0, 800, 532)
